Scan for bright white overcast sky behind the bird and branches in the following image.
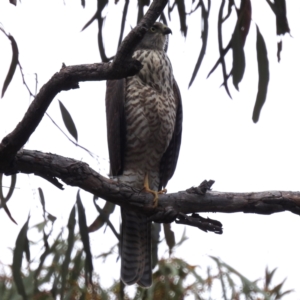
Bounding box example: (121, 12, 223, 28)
(0, 0, 300, 299)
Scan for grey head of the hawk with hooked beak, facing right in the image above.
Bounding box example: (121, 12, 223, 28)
(137, 22, 172, 51)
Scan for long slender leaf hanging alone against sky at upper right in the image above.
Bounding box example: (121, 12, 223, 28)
(252, 26, 269, 123)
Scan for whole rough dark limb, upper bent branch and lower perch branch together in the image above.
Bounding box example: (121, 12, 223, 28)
(0, 0, 300, 233)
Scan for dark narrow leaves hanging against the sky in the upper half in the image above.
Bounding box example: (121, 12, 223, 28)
(0, 0, 290, 122)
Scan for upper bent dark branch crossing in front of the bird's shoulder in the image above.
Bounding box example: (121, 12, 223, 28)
(0, 0, 168, 165)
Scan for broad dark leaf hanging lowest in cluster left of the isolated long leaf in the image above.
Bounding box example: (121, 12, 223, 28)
(231, 23, 245, 90)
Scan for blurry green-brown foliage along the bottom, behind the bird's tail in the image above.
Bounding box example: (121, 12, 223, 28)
(0, 199, 292, 300)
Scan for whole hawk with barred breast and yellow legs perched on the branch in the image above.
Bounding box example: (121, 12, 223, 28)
(106, 22, 182, 287)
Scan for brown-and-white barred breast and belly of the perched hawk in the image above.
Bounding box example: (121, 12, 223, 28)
(120, 50, 176, 190)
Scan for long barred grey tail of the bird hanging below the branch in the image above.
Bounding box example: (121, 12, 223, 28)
(121, 209, 152, 287)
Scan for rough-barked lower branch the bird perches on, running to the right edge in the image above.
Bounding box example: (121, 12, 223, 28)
(4, 150, 300, 220)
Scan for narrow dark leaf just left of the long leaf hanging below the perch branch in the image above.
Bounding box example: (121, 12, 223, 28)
(60, 205, 76, 299)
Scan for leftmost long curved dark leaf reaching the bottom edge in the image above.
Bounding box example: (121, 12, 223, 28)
(12, 217, 29, 300)
